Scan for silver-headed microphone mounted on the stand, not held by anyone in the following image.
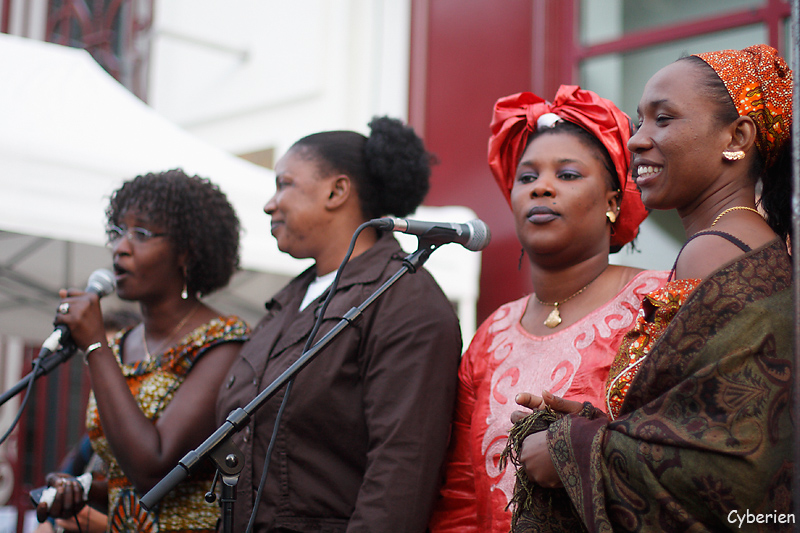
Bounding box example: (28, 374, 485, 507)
(371, 217, 492, 252)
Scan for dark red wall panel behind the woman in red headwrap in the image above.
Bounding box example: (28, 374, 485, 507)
(409, 0, 533, 321)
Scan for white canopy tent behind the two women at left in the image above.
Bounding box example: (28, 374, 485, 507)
(0, 34, 480, 341)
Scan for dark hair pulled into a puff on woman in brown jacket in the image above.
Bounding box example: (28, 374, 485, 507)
(290, 117, 434, 219)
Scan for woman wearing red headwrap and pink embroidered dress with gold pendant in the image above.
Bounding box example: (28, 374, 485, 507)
(430, 86, 666, 533)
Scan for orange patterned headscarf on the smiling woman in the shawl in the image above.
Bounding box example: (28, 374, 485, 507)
(695, 44, 792, 167)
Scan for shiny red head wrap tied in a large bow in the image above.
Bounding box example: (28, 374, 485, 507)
(489, 85, 647, 248)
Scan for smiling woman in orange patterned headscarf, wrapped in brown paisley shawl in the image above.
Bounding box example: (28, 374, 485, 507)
(512, 45, 795, 532)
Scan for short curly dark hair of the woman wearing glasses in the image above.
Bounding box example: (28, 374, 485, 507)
(106, 169, 240, 296)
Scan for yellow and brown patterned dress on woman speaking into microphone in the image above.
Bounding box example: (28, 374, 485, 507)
(86, 316, 249, 533)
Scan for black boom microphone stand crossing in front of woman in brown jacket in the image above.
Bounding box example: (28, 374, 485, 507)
(139, 243, 441, 533)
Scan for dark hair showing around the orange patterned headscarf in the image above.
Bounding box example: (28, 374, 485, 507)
(678, 56, 792, 240)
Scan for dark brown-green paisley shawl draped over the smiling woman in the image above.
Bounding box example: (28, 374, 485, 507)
(515, 240, 800, 533)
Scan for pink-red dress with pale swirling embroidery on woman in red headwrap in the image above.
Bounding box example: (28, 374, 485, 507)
(431, 271, 668, 533)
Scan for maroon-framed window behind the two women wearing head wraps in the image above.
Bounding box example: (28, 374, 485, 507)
(574, 0, 791, 269)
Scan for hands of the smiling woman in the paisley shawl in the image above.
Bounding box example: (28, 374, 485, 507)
(511, 391, 583, 489)
